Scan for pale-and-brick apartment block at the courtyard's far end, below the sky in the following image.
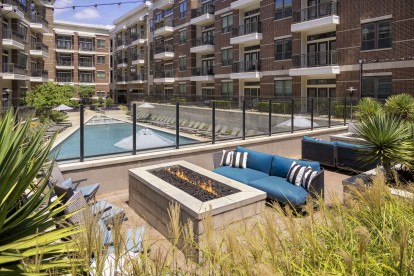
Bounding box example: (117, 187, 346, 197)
(52, 20, 110, 98)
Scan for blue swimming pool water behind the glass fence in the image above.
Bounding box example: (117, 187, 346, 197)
(51, 117, 197, 160)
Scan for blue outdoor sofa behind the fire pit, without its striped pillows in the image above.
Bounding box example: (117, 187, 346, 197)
(213, 146, 324, 205)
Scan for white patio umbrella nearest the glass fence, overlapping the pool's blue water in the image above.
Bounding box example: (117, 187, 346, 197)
(114, 128, 174, 150)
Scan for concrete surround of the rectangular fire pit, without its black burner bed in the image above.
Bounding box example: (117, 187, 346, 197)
(129, 161, 266, 247)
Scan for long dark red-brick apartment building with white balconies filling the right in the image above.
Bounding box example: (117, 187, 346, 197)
(109, 0, 414, 103)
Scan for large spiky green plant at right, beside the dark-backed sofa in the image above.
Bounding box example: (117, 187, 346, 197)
(355, 113, 414, 172)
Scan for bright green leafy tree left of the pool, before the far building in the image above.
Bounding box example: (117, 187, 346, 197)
(25, 82, 73, 114)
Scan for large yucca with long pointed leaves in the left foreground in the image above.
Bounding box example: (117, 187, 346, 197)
(0, 111, 80, 275)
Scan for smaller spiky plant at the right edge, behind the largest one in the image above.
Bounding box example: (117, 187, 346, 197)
(384, 94, 414, 122)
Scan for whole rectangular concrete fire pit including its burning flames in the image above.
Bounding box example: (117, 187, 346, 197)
(129, 161, 266, 251)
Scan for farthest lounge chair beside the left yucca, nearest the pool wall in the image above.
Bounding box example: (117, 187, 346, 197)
(50, 164, 100, 201)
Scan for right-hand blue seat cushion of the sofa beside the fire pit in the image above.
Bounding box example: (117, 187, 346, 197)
(249, 176, 308, 205)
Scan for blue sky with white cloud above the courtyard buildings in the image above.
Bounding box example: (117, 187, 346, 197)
(55, 0, 146, 26)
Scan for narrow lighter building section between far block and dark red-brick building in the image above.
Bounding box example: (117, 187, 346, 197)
(110, 4, 149, 103)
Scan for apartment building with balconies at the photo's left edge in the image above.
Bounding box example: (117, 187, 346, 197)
(0, 0, 54, 108)
